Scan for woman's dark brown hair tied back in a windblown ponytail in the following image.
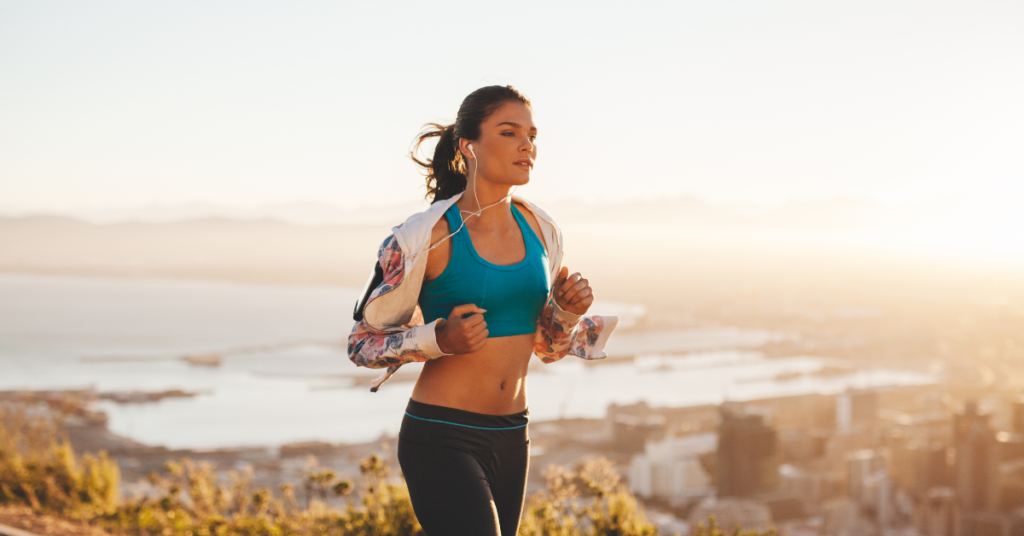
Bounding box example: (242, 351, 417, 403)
(410, 86, 530, 204)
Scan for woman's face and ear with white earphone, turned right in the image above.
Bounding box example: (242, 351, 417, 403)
(460, 101, 537, 185)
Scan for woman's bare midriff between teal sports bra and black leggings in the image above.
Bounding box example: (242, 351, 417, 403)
(413, 333, 534, 415)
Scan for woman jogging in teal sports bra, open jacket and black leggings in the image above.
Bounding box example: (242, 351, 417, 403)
(348, 86, 617, 536)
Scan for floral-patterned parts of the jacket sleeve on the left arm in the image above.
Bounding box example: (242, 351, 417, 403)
(348, 235, 445, 372)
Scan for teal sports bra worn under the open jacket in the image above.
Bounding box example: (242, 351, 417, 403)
(420, 204, 551, 338)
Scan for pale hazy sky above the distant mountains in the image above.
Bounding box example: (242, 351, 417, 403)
(0, 0, 1024, 211)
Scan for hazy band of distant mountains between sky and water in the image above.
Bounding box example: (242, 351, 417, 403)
(0, 197, 1024, 294)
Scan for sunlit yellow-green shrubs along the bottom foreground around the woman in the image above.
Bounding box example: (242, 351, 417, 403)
(0, 402, 773, 536)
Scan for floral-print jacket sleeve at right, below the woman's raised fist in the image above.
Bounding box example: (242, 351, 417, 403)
(534, 293, 618, 363)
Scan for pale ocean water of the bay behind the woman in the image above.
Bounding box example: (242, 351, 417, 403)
(0, 275, 934, 448)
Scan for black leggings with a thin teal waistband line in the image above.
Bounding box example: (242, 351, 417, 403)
(398, 399, 529, 536)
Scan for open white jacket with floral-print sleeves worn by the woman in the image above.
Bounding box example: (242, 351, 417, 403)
(348, 194, 618, 391)
